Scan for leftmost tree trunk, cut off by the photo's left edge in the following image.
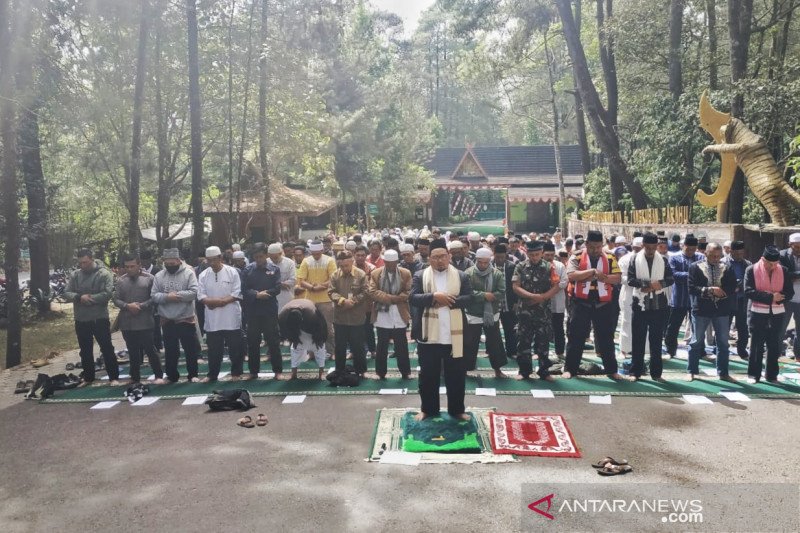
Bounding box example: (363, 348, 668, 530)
(0, 0, 22, 368)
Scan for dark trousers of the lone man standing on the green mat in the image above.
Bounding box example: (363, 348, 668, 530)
(417, 344, 467, 416)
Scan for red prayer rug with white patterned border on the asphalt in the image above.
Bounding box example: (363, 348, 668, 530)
(489, 412, 581, 457)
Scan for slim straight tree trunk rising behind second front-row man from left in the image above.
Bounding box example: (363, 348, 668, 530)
(128, 0, 150, 253)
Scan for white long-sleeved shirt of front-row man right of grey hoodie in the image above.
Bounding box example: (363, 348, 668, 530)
(197, 265, 242, 332)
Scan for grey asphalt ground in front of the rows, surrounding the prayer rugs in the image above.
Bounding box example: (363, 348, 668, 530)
(0, 387, 800, 533)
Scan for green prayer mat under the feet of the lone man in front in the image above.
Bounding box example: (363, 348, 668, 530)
(401, 412, 481, 453)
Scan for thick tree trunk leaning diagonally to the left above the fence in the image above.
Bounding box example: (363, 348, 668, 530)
(557, 0, 650, 209)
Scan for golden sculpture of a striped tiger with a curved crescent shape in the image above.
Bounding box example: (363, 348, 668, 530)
(697, 93, 800, 226)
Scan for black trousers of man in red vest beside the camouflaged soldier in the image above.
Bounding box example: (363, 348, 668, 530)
(564, 302, 618, 376)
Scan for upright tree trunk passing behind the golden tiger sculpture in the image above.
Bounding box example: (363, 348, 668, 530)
(728, 0, 753, 224)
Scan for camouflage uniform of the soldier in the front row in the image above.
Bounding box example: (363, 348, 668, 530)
(512, 259, 553, 378)
